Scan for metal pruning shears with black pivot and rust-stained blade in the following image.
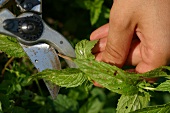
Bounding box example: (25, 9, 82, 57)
(0, 0, 76, 98)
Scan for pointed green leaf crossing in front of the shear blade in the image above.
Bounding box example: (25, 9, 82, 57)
(33, 68, 86, 88)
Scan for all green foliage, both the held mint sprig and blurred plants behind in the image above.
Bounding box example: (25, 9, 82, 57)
(0, 0, 170, 113)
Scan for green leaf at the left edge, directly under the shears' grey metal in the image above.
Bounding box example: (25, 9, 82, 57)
(0, 35, 26, 58)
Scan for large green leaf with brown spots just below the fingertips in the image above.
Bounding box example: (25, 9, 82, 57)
(74, 59, 138, 94)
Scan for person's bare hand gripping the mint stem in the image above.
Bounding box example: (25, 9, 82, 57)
(90, 0, 170, 73)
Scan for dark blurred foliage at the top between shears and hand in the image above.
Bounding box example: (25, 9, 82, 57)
(43, 0, 113, 44)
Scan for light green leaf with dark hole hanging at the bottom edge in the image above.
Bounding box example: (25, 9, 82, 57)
(117, 93, 150, 113)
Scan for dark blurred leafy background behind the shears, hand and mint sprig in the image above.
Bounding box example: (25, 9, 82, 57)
(0, 0, 170, 113)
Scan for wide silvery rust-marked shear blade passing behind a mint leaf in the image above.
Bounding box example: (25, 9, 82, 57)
(20, 43, 61, 99)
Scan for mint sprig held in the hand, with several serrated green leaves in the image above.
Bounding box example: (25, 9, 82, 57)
(32, 40, 170, 113)
